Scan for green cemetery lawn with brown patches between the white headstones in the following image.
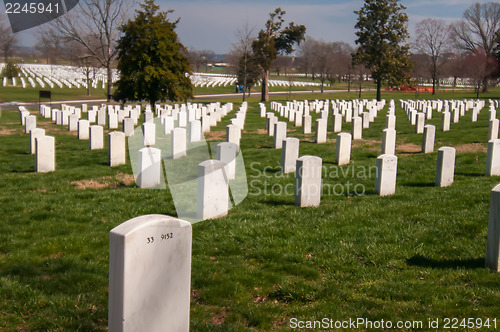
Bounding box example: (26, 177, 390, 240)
(0, 90, 500, 331)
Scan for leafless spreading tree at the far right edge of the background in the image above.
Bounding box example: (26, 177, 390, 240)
(452, 2, 500, 92)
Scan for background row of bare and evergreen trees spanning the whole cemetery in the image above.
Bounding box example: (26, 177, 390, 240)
(0, 0, 500, 102)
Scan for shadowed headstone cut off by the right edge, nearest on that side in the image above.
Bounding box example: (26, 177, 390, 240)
(486, 185, 500, 272)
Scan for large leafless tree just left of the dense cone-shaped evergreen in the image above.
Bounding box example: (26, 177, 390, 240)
(53, 0, 135, 101)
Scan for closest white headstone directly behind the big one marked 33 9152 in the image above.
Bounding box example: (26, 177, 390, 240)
(135, 147, 161, 189)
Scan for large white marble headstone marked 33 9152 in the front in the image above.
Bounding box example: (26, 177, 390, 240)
(108, 215, 192, 332)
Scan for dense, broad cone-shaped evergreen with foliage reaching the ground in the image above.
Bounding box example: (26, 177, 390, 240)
(114, 0, 193, 109)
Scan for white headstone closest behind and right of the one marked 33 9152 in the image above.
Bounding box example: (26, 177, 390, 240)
(197, 160, 229, 220)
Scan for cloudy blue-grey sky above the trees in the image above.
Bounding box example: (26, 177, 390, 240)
(15, 0, 488, 54)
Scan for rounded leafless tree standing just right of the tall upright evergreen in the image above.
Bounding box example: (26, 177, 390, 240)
(414, 18, 451, 95)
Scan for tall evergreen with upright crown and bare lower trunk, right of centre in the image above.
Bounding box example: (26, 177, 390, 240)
(353, 0, 412, 100)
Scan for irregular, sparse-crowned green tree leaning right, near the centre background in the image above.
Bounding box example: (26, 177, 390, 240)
(252, 8, 306, 101)
